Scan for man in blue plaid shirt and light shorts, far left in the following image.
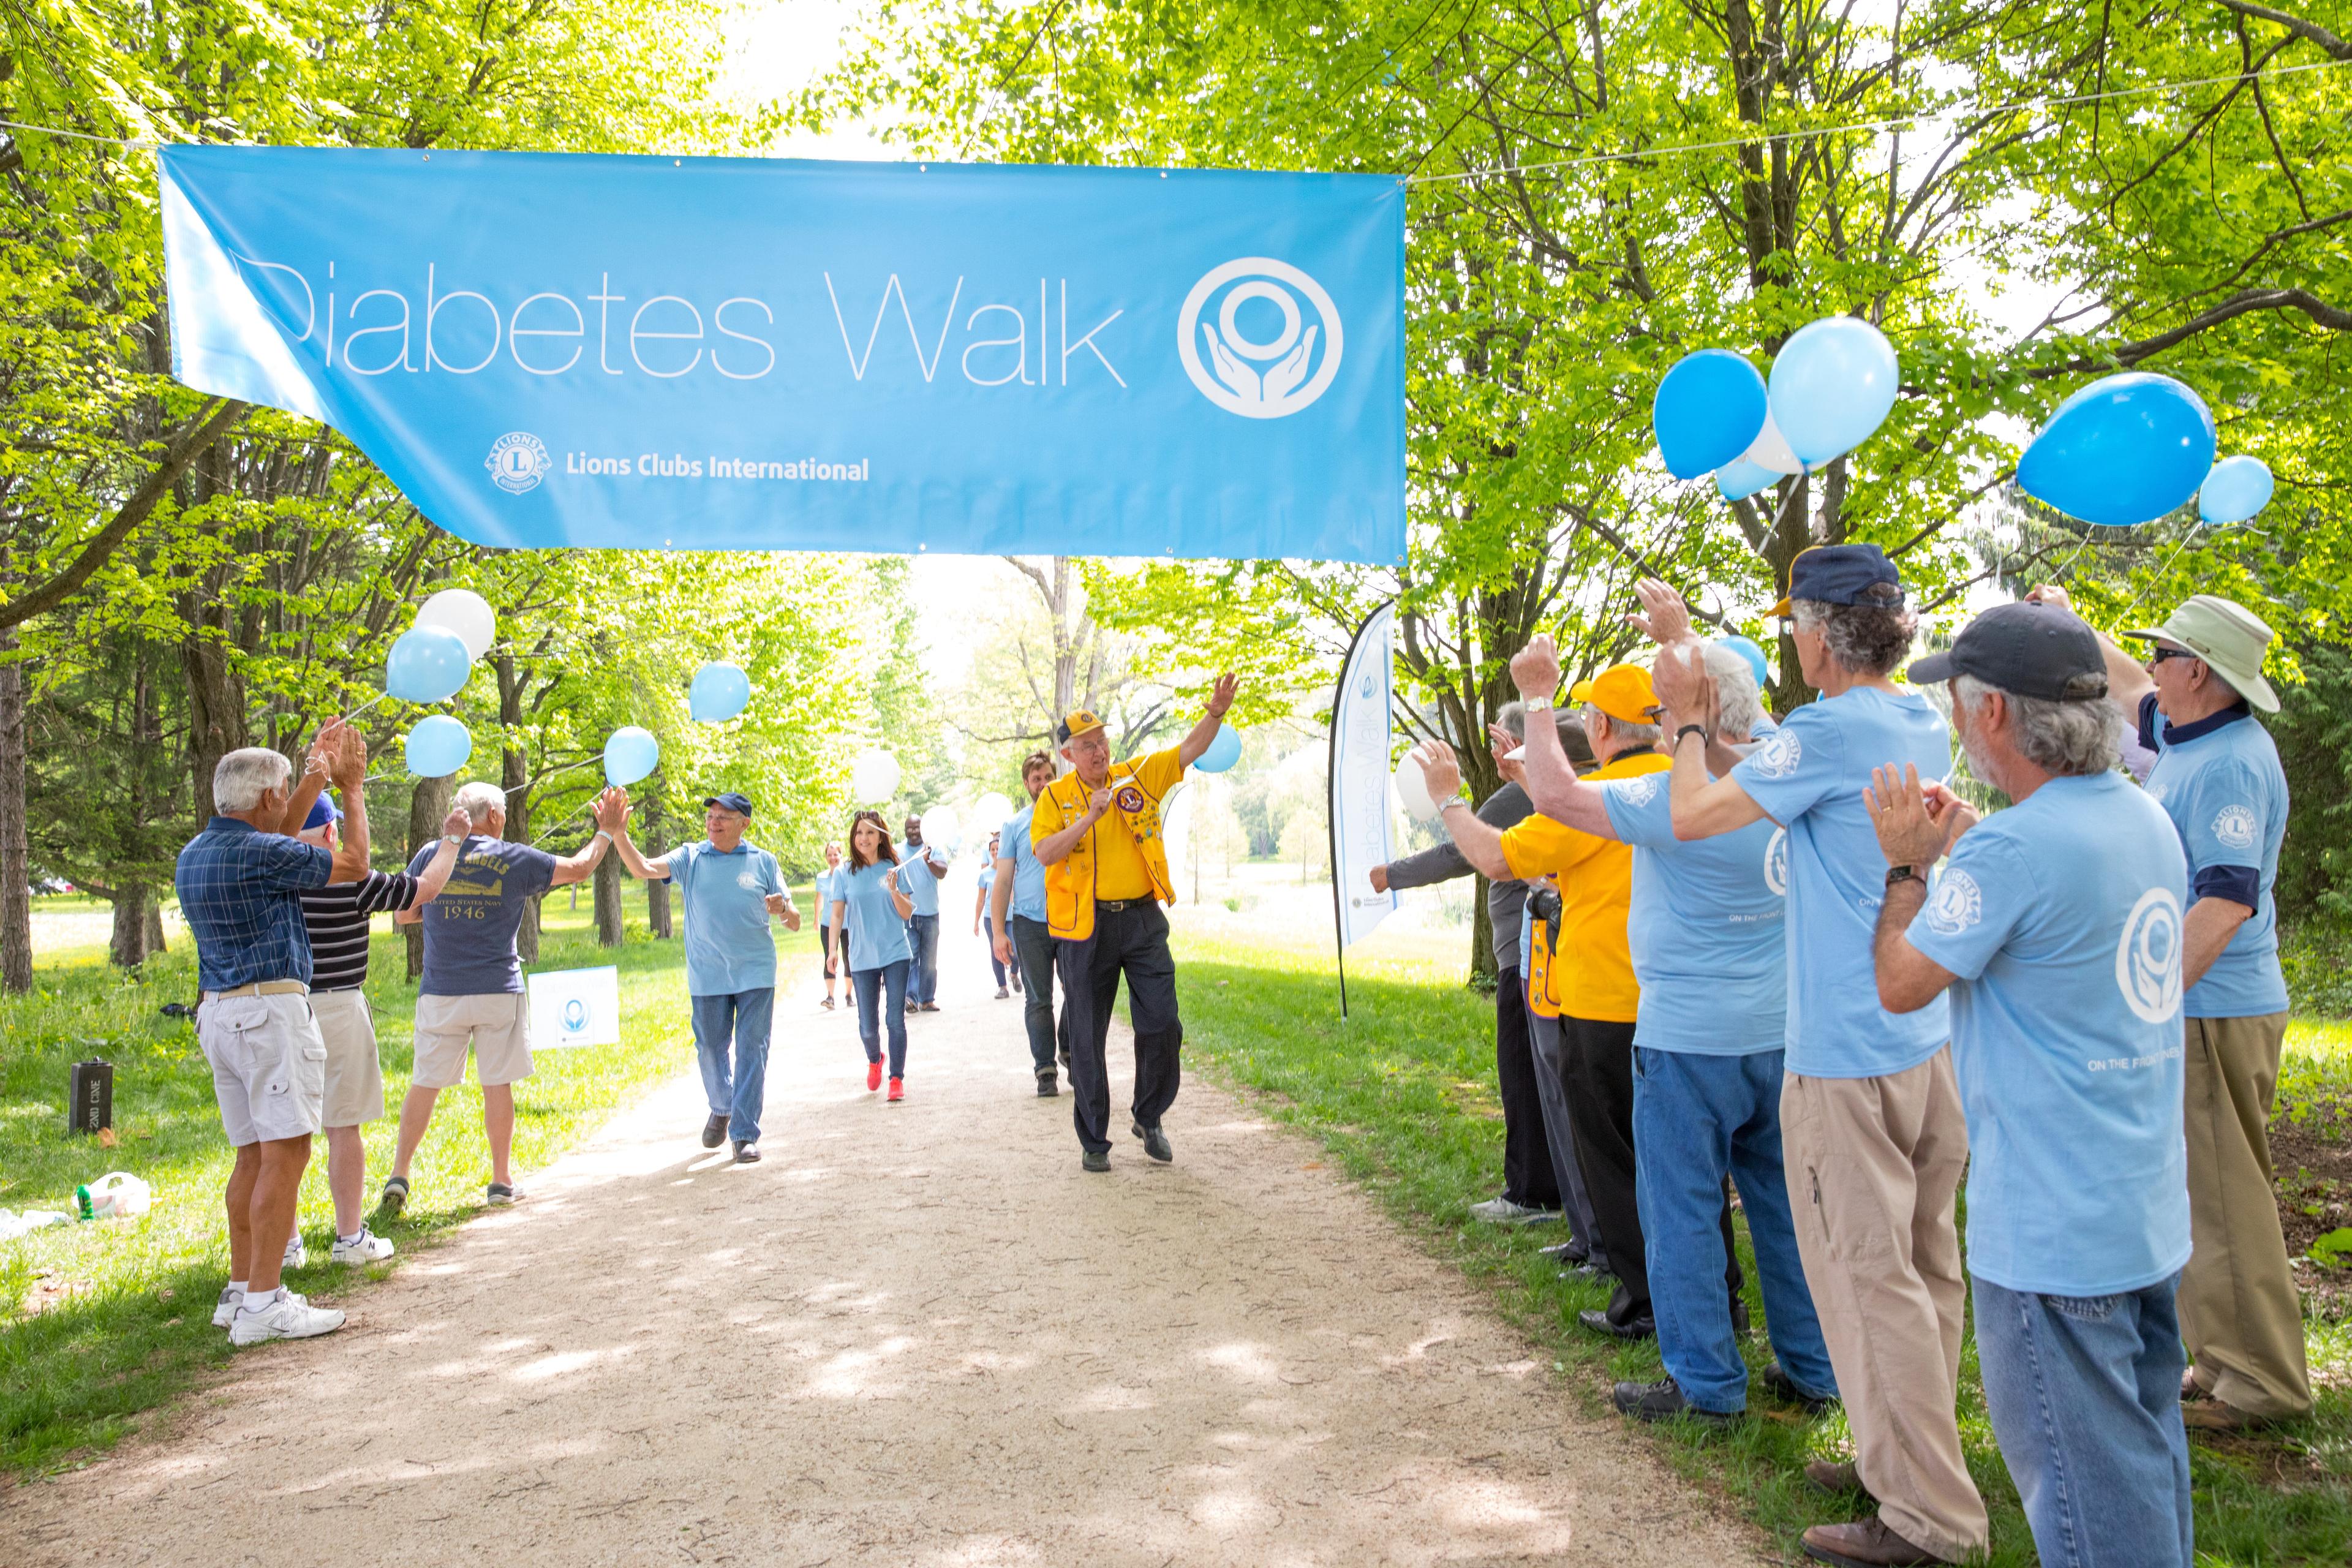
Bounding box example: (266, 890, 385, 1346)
(172, 722, 344, 1344)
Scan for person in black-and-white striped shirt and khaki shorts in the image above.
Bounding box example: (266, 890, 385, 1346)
(294, 733, 470, 1267)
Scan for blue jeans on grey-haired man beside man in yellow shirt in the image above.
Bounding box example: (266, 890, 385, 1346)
(1632, 1046, 1834, 1411)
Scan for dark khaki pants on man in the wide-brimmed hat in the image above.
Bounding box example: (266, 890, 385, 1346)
(2180, 1013, 2312, 1417)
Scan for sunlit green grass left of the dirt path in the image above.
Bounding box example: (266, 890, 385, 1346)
(0, 884, 816, 1474)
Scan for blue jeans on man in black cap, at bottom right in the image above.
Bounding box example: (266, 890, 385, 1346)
(1971, 1274, 2197, 1568)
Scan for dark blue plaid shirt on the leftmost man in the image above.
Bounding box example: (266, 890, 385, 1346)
(172, 816, 334, 992)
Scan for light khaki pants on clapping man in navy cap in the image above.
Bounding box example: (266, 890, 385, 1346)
(1781, 1049, 1985, 1559)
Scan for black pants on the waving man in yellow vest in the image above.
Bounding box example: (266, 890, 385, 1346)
(1054, 898, 1183, 1150)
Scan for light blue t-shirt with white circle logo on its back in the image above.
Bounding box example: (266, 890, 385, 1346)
(1907, 774, 2190, 1295)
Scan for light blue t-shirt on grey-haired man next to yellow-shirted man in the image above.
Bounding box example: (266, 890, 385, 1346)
(1599, 774, 1787, 1055)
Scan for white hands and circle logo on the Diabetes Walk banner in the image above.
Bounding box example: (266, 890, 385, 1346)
(1176, 256, 1343, 418)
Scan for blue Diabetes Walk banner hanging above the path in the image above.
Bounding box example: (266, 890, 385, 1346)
(157, 146, 1404, 564)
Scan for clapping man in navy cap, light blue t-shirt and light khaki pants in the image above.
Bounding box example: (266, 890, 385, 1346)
(1637, 545, 1988, 1563)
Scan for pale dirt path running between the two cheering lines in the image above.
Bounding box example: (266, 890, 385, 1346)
(0, 963, 1757, 1568)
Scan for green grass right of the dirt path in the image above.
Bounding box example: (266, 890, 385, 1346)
(1176, 931, 2352, 1568)
